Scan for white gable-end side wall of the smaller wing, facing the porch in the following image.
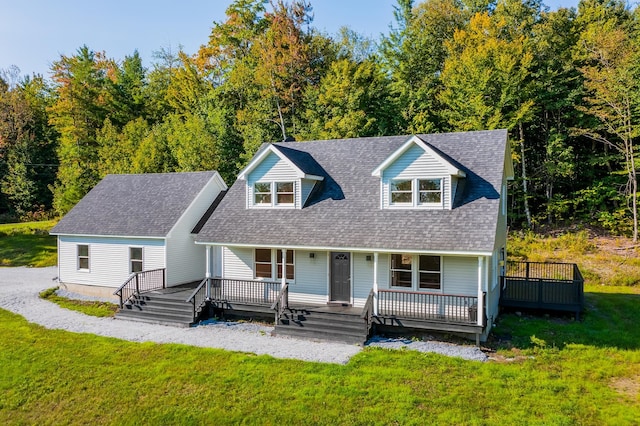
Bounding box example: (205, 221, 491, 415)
(167, 173, 223, 286)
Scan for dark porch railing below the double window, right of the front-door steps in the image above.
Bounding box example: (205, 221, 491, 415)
(378, 290, 484, 324)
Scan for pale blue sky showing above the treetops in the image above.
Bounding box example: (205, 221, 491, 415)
(0, 0, 578, 77)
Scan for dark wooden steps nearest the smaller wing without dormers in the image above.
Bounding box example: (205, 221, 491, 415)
(116, 292, 194, 327)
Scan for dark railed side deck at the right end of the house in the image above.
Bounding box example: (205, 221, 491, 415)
(500, 261, 584, 315)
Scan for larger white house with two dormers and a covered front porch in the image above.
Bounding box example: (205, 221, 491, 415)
(195, 130, 513, 339)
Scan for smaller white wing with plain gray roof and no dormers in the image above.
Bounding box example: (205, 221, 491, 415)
(51, 172, 227, 297)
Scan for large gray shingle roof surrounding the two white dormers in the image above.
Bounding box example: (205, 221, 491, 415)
(196, 130, 507, 252)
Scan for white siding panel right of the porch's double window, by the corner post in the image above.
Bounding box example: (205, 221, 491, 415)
(442, 256, 478, 296)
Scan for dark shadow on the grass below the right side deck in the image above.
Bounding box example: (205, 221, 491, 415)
(490, 292, 640, 350)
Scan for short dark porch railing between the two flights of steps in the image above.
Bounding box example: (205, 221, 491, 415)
(211, 278, 281, 306)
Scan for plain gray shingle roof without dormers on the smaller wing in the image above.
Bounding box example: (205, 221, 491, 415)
(51, 171, 215, 237)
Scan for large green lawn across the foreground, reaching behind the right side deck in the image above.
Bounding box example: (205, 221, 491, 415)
(0, 230, 640, 425)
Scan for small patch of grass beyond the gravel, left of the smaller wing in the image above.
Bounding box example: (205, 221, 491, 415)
(0, 220, 58, 267)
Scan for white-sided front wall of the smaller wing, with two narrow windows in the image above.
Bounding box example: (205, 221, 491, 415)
(58, 235, 165, 289)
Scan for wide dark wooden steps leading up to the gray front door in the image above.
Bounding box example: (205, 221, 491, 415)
(275, 309, 368, 345)
